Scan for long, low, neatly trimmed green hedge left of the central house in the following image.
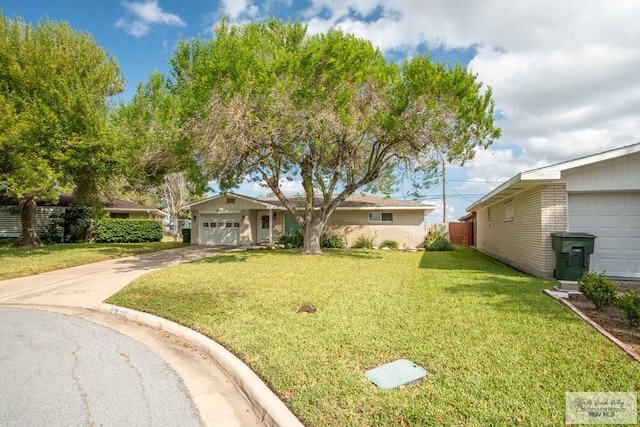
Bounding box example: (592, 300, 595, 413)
(96, 218, 162, 243)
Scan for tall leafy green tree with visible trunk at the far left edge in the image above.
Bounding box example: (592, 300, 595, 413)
(0, 12, 124, 245)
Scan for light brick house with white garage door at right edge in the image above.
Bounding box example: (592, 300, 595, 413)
(466, 144, 640, 279)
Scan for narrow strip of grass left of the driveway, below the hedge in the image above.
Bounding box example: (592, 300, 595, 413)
(0, 239, 184, 280)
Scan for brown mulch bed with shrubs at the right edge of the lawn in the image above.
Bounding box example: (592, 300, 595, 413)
(569, 295, 640, 354)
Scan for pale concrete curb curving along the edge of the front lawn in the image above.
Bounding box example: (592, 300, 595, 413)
(97, 303, 304, 427)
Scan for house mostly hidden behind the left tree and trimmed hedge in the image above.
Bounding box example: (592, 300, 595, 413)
(0, 194, 168, 238)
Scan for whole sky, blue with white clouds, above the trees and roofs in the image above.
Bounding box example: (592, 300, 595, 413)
(0, 0, 640, 222)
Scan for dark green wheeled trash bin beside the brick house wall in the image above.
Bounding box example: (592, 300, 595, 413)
(551, 232, 596, 281)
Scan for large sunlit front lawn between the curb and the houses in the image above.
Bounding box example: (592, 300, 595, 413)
(109, 247, 640, 426)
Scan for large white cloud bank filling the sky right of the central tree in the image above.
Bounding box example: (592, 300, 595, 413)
(298, 0, 640, 212)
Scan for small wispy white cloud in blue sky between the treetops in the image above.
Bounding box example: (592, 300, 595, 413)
(115, 0, 186, 37)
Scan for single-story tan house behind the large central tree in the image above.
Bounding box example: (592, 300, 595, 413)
(183, 193, 435, 247)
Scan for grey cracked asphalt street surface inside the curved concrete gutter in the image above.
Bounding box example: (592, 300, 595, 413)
(0, 307, 203, 426)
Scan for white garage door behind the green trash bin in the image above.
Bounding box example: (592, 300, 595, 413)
(569, 192, 640, 278)
